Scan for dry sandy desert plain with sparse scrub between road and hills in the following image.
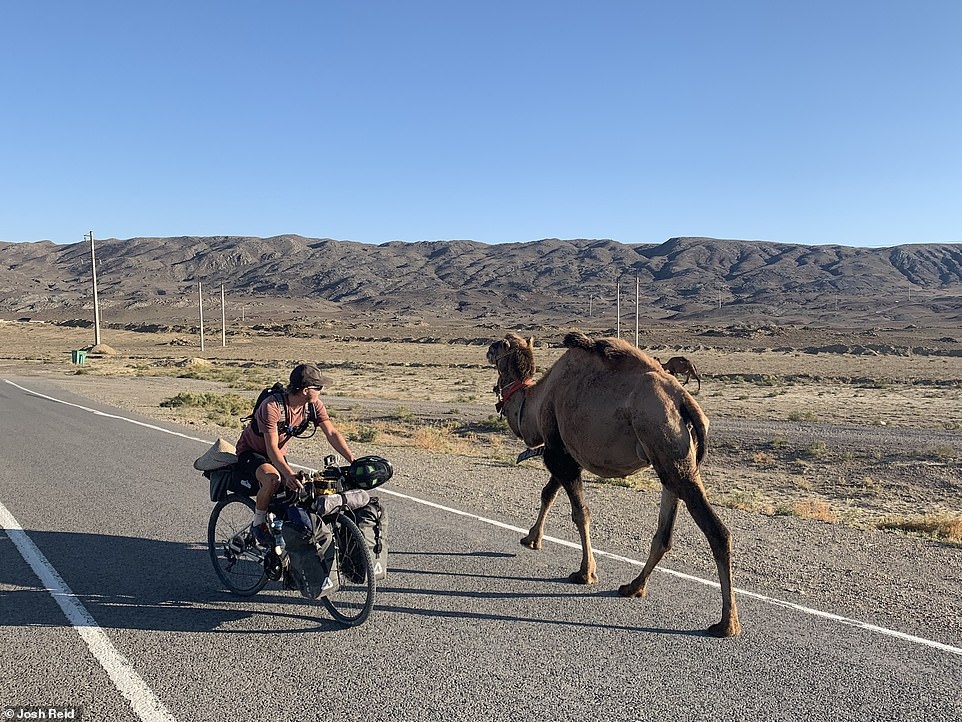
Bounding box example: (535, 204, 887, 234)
(0, 321, 962, 544)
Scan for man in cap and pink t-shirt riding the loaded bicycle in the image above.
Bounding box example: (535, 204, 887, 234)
(237, 364, 354, 546)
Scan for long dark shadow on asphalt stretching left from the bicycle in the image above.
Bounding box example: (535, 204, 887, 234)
(0, 530, 344, 634)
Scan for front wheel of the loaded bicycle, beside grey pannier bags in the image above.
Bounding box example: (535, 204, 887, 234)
(321, 514, 375, 626)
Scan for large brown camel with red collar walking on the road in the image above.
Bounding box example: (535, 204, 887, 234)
(487, 332, 741, 637)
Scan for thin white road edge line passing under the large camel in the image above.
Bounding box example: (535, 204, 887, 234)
(4, 379, 962, 656)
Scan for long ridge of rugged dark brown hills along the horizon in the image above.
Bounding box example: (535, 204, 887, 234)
(0, 235, 962, 327)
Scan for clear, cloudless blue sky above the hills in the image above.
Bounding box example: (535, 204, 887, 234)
(0, 0, 962, 246)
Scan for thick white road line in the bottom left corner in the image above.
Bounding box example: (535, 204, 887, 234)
(0, 502, 175, 722)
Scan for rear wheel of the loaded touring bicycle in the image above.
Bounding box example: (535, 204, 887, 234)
(207, 494, 268, 597)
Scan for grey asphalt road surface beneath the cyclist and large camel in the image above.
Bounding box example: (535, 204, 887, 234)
(0, 379, 962, 721)
